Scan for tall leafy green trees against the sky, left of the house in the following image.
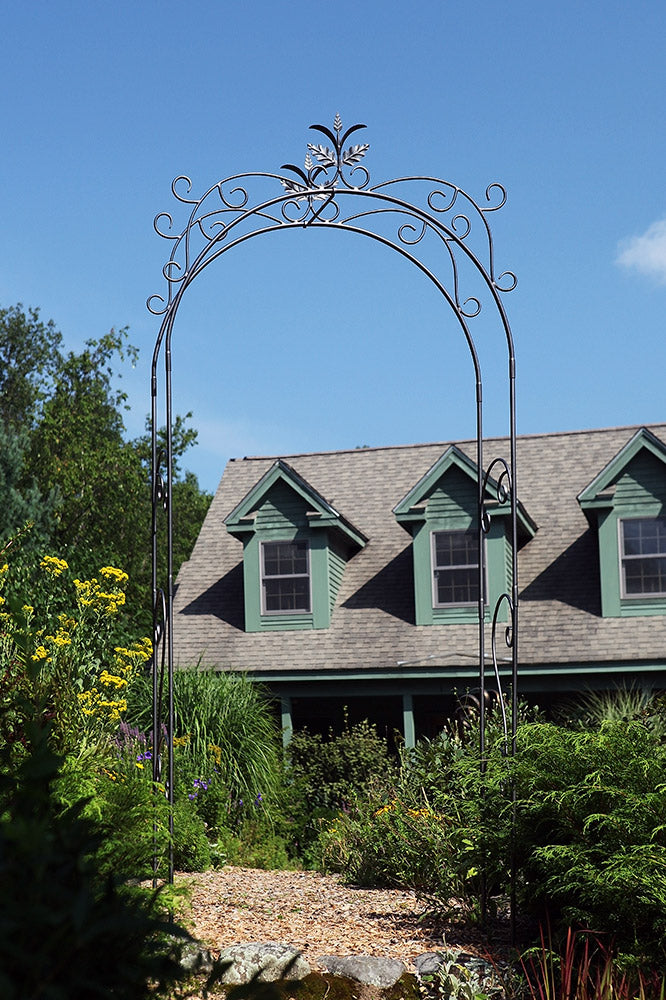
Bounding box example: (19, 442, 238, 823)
(0, 305, 212, 630)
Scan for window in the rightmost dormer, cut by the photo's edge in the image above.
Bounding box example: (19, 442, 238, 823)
(620, 517, 666, 598)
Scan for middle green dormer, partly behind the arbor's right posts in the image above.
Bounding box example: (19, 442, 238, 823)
(393, 445, 537, 625)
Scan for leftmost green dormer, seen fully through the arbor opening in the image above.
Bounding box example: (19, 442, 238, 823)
(224, 459, 367, 632)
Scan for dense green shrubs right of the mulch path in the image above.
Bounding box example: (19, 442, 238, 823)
(321, 696, 666, 968)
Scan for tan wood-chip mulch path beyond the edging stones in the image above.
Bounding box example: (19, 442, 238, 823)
(176, 866, 486, 969)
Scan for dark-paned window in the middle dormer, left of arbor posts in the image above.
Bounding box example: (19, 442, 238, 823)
(432, 531, 479, 608)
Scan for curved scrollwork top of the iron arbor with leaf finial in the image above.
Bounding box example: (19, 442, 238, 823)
(147, 114, 517, 356)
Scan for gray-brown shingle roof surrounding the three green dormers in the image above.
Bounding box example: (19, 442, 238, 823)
(174, 424, 666, 673)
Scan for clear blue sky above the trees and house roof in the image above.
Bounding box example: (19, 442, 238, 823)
(0, 0, 666, 489)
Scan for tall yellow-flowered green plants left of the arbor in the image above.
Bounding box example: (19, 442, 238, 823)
(0, 547, 179, 877)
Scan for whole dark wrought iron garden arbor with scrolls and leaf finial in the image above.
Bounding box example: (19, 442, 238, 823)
(147, 115, 518, 892)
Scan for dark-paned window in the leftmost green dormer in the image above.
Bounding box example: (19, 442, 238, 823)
(261, 541, 310, 614)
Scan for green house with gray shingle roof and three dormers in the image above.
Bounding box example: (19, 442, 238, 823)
(174, 424, 666, 743)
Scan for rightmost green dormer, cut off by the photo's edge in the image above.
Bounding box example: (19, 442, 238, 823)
(578, 427, 666, 618)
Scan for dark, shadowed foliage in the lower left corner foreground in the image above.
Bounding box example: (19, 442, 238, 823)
(0, 713, 192, 1000)
